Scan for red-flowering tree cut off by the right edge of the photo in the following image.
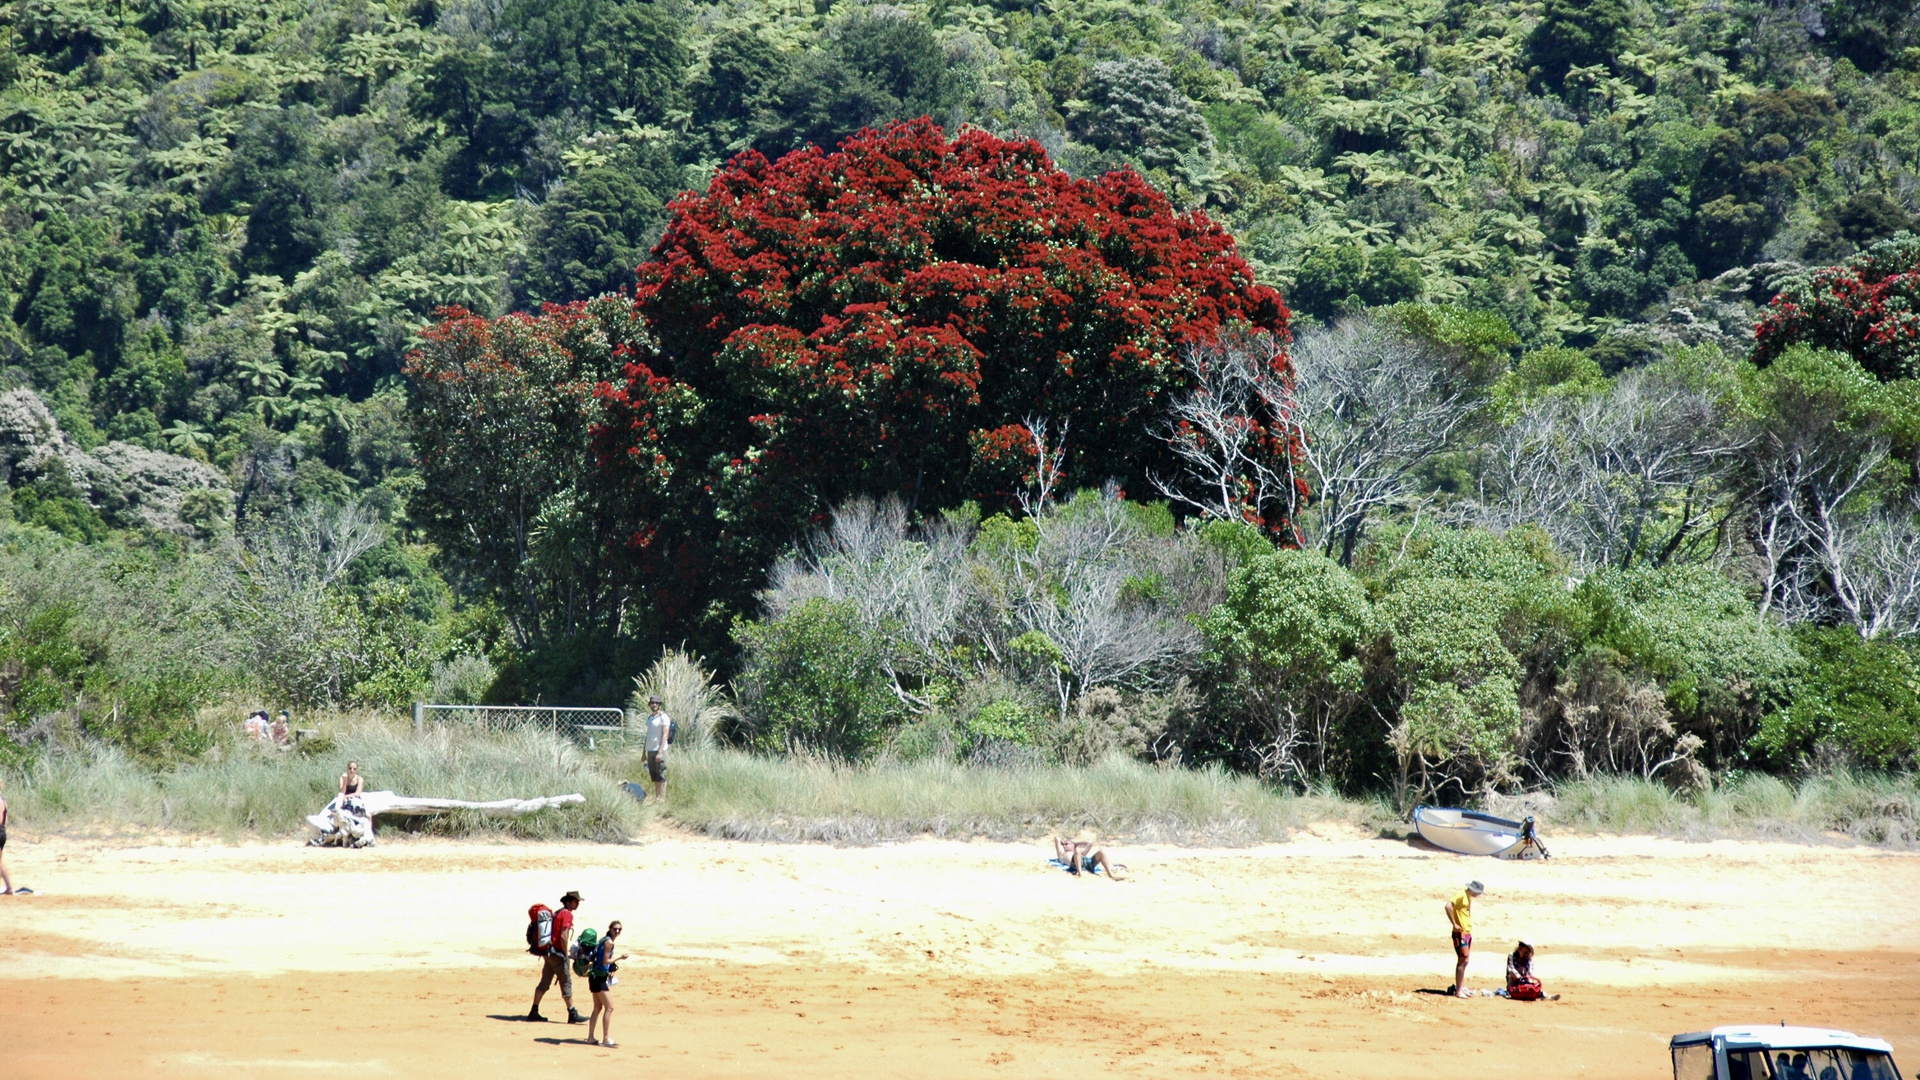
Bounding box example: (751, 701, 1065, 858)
(1753, 236, 1920, 380)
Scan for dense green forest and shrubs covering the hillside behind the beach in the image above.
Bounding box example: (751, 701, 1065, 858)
(0, 0, 1920, 792)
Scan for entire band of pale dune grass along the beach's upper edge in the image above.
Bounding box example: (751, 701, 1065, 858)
(6, 715, 1920, 847)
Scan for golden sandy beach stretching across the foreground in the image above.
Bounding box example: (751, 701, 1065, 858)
(0, 830, 1920, 1080)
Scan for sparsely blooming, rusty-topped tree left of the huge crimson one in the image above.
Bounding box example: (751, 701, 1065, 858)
(407, 298, 687, 650)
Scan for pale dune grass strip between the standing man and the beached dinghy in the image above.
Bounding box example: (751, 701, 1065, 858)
(648, 749, 1382, 844)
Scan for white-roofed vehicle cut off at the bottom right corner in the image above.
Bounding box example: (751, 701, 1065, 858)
(1668, 1024, 1901, 1080)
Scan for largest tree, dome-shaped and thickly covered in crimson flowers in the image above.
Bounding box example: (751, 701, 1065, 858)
(428, 119, 1288, 657)
